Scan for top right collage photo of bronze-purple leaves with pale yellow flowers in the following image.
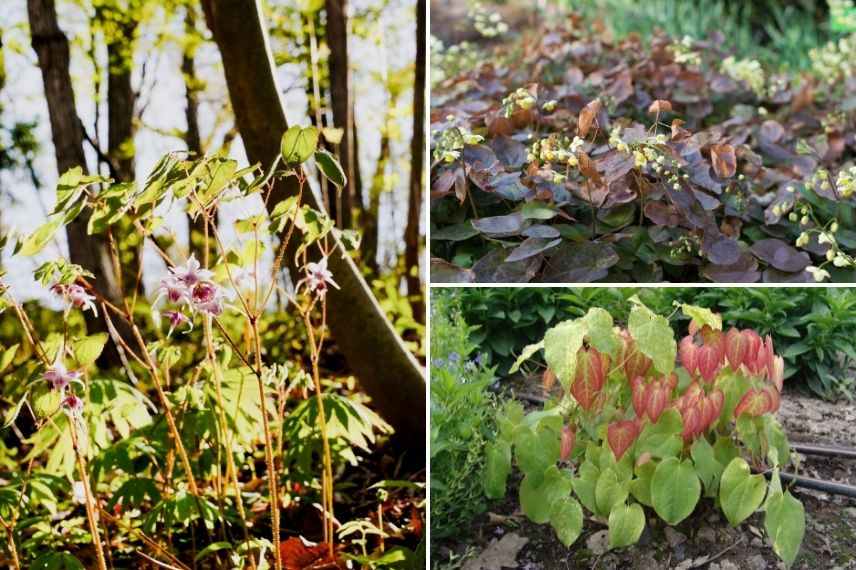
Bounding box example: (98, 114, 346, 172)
(429, 0, 856, 283)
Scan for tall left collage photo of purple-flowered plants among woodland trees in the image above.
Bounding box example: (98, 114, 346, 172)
(0, 0, 428, 570)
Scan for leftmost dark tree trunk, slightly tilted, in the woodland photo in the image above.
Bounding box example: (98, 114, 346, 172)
(27, 0, 127, 366)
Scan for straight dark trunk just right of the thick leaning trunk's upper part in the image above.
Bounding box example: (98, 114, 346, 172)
(325, 0, 362, 228)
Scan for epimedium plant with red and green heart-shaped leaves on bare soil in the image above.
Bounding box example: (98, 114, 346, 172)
(485, 300, 805, 564)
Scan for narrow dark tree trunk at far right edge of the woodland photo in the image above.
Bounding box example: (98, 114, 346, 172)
(404, 0, 426, 322)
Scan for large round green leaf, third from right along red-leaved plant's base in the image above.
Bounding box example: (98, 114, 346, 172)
(651, 457, 701, 525)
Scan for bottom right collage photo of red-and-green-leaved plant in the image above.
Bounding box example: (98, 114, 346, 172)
(430, 286, 856, 569)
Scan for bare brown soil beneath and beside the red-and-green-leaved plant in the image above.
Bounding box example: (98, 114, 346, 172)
(432, 377, 856, 570)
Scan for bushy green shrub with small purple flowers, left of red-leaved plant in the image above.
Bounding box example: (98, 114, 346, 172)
(431, 289, 495, 537)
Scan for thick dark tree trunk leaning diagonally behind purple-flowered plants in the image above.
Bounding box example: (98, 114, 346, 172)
(203, 0, 425, 446)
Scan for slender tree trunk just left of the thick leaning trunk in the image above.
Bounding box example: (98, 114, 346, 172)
(181, 4, 211, 260)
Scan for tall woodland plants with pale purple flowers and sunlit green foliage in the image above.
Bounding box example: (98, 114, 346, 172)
(0, 127, 421, 570)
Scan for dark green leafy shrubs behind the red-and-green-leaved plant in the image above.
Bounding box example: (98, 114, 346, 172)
(459, 287, 856, 399)
